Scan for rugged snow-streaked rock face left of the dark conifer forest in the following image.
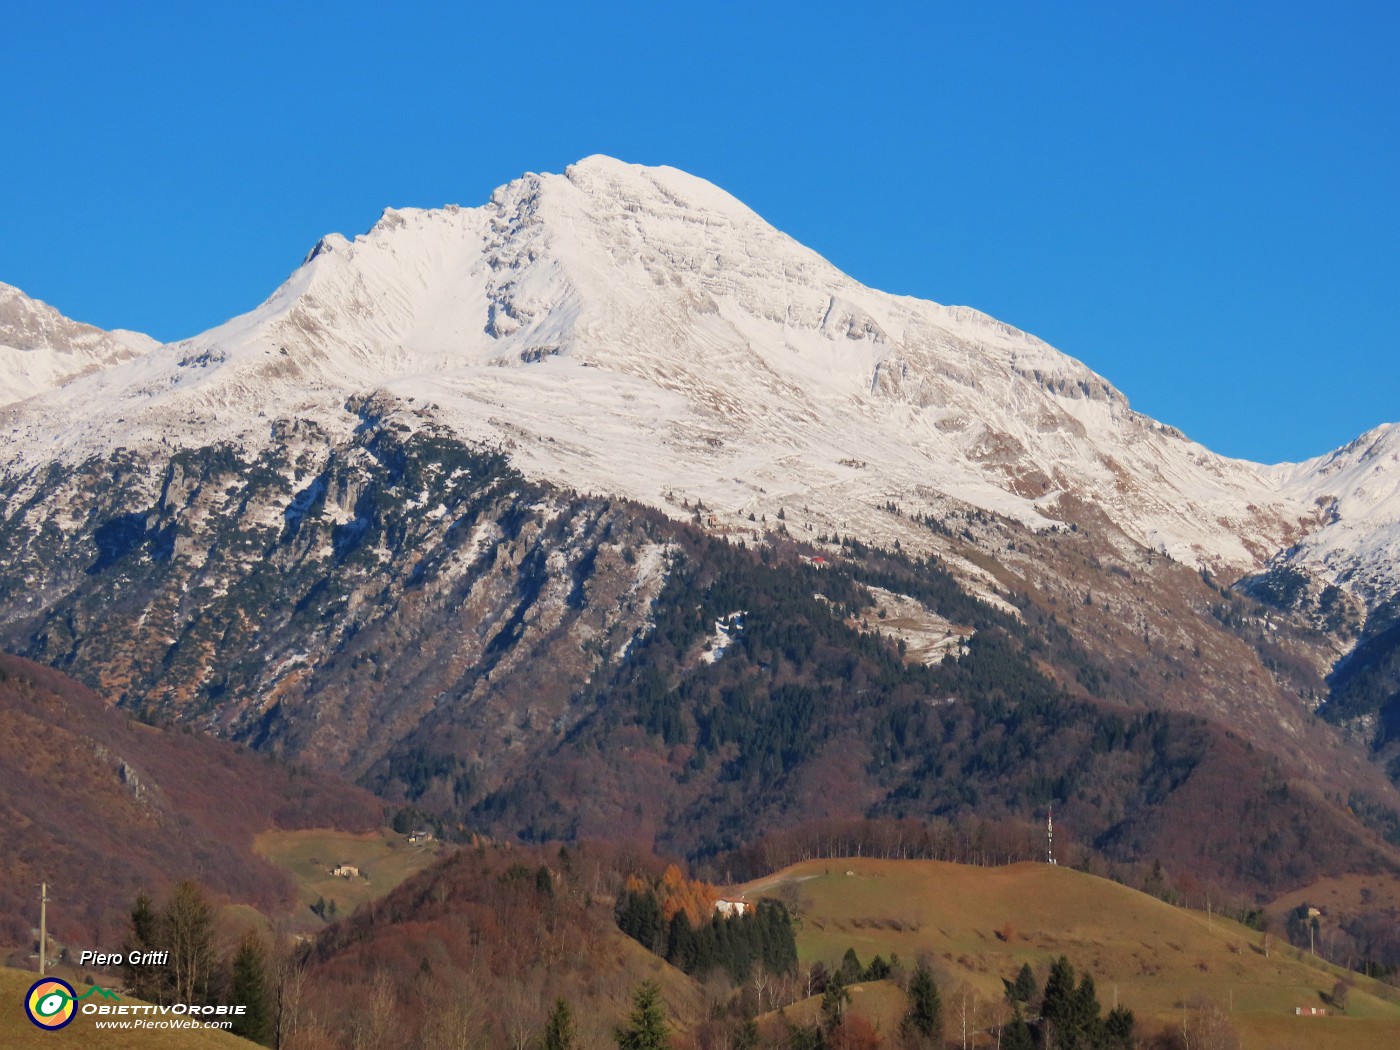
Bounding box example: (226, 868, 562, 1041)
(0, 414, 668, 800)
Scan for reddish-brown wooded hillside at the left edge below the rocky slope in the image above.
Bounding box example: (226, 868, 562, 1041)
(0, 654, 381, 951)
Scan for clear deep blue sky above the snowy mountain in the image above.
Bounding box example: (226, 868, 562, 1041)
(0, 0, 1400, 461)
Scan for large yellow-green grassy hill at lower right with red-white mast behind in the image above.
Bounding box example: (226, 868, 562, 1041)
(743, 860, 1400, 1047)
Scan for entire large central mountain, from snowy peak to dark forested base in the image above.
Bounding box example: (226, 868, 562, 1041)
(8, 158, 1400, 907)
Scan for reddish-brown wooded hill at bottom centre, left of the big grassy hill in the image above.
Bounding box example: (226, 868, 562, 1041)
(293, 844, 706, 1050)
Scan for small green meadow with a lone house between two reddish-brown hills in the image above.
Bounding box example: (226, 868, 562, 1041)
(253, 827, 444, 930)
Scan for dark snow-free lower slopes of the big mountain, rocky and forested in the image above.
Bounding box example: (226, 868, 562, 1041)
(0, 422, 1400, 907)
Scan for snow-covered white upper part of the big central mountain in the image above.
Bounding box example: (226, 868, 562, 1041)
(2, 157, 1400, 602)
